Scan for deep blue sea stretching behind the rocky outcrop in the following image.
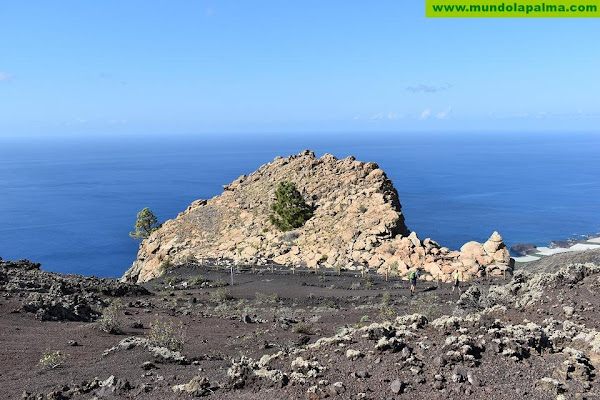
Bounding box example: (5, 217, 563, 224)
(0, 133, 600, 277)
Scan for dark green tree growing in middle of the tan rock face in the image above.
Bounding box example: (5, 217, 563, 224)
(269, 181, 313, 232)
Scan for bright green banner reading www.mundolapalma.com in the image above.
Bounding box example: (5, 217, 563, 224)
(425, 0, 600, 18)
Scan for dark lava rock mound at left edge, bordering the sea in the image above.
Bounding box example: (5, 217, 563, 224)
(0, 259, 150, 322)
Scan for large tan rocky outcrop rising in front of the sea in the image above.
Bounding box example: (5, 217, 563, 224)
(123, 150, 509, 282)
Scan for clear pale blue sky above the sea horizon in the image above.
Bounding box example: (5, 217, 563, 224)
(0, 0, 600, 136)
